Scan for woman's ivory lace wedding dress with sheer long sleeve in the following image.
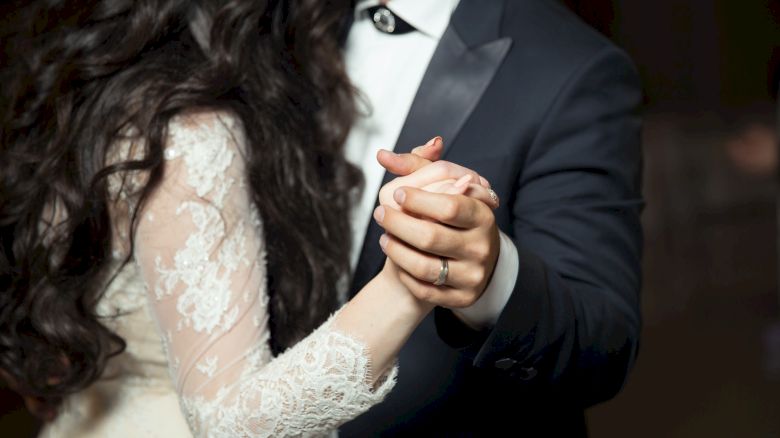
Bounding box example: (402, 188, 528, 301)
(41, 113, 396, 438)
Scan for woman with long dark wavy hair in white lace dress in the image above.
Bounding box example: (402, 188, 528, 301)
(0, 0, 490, 437)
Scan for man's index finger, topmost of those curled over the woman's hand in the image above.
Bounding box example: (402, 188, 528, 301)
(393, 187, 487, 228)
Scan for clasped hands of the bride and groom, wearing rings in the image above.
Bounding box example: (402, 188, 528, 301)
(374, 137, 499, 308)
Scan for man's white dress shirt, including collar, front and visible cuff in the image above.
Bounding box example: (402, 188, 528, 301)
(346, 0, 519, 328)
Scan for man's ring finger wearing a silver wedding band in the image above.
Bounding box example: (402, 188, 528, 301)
(379, 234, 485, 290)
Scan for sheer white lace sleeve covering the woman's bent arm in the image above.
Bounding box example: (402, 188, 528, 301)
(135, 114, 396, 437)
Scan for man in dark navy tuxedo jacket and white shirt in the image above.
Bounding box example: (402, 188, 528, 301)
(340, 0, 642, 437)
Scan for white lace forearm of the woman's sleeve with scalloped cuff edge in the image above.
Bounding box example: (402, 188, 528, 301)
(183, 316, 397, 437)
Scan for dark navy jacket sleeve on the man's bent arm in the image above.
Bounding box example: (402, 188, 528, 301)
(436, 47, 643, 406)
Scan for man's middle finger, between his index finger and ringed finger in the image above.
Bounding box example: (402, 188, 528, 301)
(374, 206, 469, 258)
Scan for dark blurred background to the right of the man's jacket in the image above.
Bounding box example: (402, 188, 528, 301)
(0, 0, 780, 438)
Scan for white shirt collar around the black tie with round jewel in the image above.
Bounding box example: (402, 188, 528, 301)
(355, 0, 460, 40)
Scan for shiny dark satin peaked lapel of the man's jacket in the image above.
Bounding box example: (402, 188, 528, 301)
(351, 0, 512, 294)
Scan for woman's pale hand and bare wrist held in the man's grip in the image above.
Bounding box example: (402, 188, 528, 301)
(334, 139, 500, 384)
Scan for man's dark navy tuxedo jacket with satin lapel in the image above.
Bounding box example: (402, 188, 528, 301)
(341, 0, 642, 437)
